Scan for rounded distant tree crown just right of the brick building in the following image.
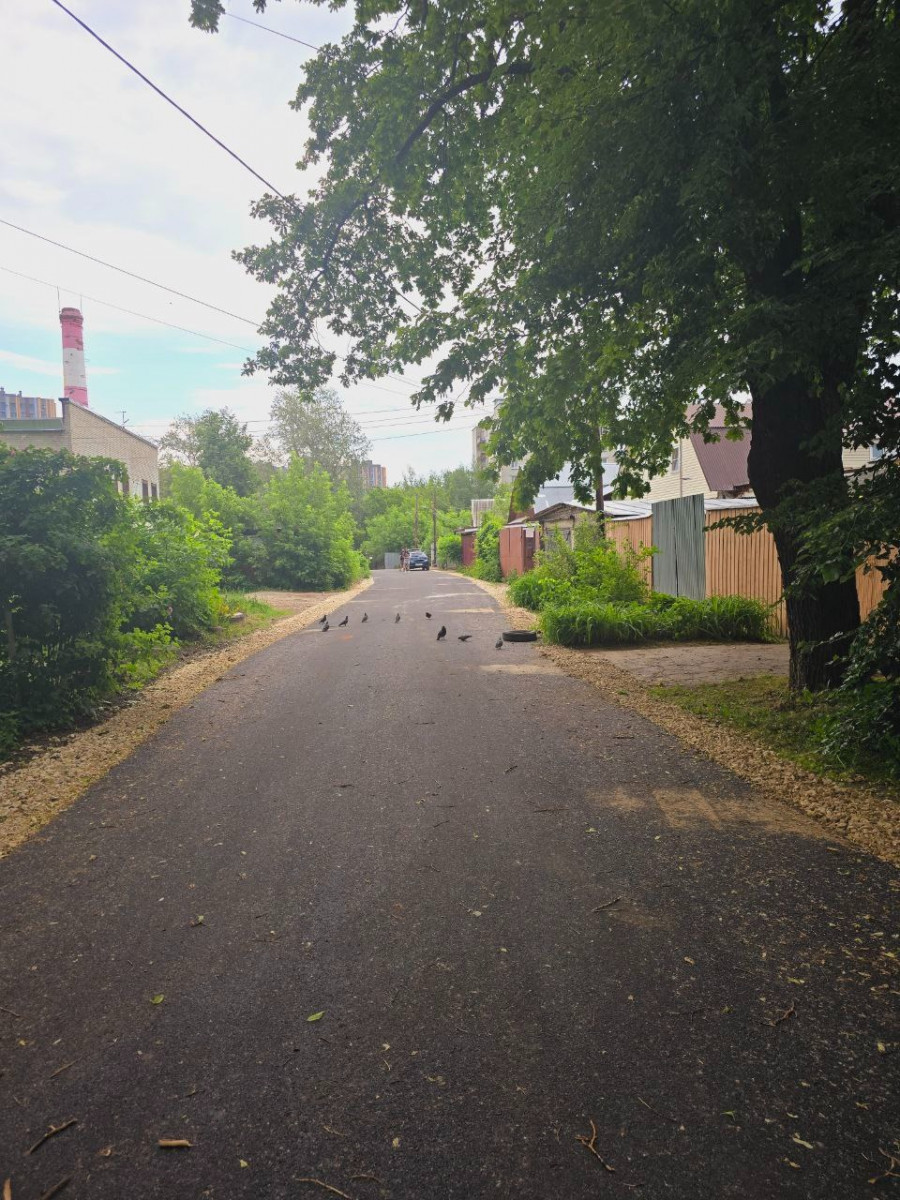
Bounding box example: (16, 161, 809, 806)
(160, 408, 258, 496)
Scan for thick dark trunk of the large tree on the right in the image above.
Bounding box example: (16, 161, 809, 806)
(748, 378, 859, 691)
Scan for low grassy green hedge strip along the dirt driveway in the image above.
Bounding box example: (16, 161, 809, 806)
(541, 596, 772, 646)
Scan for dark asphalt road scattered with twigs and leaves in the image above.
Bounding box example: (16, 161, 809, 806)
(0, 572, 900, 1200)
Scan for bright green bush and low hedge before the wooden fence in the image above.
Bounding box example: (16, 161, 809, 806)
(509, 520, 773, 646)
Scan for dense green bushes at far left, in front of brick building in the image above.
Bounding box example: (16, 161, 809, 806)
(0, 445, 240, 755)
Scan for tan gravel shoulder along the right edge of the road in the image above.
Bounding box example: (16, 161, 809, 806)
(473, 580, 900, 866)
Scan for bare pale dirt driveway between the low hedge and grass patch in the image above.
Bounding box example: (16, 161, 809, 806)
(594, 642, 790, 688)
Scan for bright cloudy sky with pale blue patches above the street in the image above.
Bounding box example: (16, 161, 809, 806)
(0, 0, 480, 482)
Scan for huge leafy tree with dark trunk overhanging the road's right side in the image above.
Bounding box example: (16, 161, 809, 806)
(193, 0, 900, 688)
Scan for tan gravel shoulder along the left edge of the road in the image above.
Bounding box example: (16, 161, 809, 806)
(0, 580, 372, 858)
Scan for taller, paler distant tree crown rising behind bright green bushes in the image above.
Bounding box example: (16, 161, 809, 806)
(270, 388, 370, 491)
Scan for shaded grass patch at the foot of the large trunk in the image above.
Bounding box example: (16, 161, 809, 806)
(650, 676, 900, 799)
